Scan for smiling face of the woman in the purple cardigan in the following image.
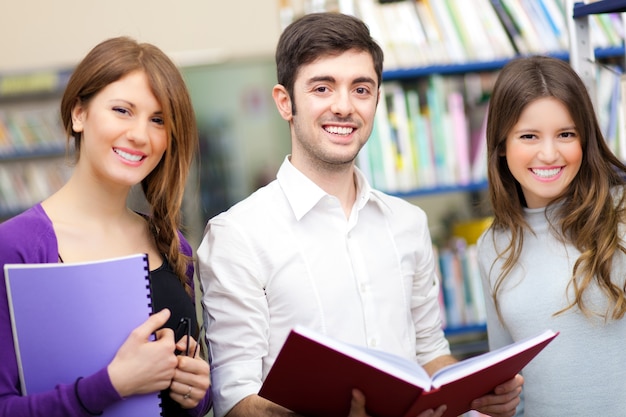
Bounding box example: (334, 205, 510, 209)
(72, 71, 168, 187)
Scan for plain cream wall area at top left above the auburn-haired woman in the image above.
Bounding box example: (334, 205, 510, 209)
(0, 0, 280, 74)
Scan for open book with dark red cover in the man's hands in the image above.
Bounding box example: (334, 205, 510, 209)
(259, 326, 558, 417)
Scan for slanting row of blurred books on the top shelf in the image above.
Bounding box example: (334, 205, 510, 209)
(281, 0, 624, 70)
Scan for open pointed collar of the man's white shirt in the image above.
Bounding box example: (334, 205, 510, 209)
(276, 155, 390, 220)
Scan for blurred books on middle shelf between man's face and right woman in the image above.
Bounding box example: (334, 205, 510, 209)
(357, 73, 496, 193)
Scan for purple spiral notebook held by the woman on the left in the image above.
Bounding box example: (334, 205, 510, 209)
(4, 254, 161, 417)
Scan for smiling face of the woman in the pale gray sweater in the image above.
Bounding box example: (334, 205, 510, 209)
(506, 97, 583, 208)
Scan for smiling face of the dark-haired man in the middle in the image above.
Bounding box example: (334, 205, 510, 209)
(274, 50, 378, 172)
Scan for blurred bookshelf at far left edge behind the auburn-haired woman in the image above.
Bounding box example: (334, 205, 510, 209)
(0, 70, 71, 221)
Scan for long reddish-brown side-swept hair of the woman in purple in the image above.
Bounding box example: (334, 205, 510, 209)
(61, 37, 198, 292)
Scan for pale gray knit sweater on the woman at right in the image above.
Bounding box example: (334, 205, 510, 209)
(478, 209, 626, 417)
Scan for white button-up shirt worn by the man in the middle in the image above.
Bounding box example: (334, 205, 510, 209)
(198, 159, 450, 417)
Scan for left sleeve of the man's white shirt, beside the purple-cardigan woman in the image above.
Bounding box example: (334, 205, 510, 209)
(198, 216, 269, 417)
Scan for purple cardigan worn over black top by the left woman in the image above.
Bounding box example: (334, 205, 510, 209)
(0, 204, 211, 417)
